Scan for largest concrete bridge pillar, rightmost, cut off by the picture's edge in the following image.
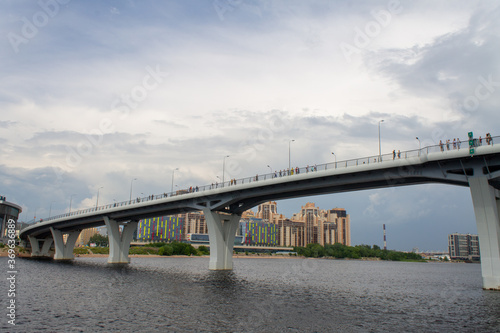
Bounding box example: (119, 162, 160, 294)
(469, 177, 500, 290)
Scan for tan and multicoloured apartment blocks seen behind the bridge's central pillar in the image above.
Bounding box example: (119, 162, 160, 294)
(136, 201, 351, 247)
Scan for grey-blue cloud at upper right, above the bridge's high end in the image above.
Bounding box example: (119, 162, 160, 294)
(365, 3, 500, 130)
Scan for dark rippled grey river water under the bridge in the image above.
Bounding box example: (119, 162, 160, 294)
(0, 257, 500, 333)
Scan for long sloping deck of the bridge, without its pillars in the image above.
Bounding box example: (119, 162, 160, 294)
(20, 137, 500, 239)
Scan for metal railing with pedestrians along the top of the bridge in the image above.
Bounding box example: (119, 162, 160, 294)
(27, 136, 500, 227)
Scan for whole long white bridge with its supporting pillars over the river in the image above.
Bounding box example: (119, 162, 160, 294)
(20, 137, 500, 290)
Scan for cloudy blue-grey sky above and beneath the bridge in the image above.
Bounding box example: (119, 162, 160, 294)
(0, 0, 500, 251)
